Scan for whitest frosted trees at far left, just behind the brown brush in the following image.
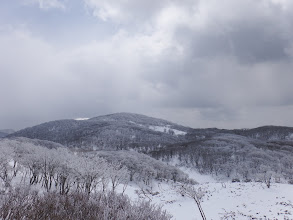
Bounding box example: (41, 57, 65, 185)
(0, 140, 129, 194)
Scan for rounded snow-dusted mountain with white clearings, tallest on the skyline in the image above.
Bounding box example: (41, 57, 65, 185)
(9, 113, 192, 151)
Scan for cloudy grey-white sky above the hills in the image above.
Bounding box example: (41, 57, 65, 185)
(0, 0, 293, 130)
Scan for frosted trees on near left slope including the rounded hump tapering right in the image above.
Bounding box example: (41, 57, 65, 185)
(0, 139, 190, 194)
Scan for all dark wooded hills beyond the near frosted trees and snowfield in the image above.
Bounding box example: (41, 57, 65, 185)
(8, 113, 293, 181)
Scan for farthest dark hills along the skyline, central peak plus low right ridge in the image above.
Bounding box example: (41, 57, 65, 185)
(9, 113, 293, 151)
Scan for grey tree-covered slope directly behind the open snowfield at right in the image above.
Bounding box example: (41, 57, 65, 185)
(151, 134, 293, 181)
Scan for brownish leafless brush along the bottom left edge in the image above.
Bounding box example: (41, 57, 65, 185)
(0, 189, 171, 220)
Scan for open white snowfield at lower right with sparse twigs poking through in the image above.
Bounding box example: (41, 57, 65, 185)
(121, 174, 293, 220)
